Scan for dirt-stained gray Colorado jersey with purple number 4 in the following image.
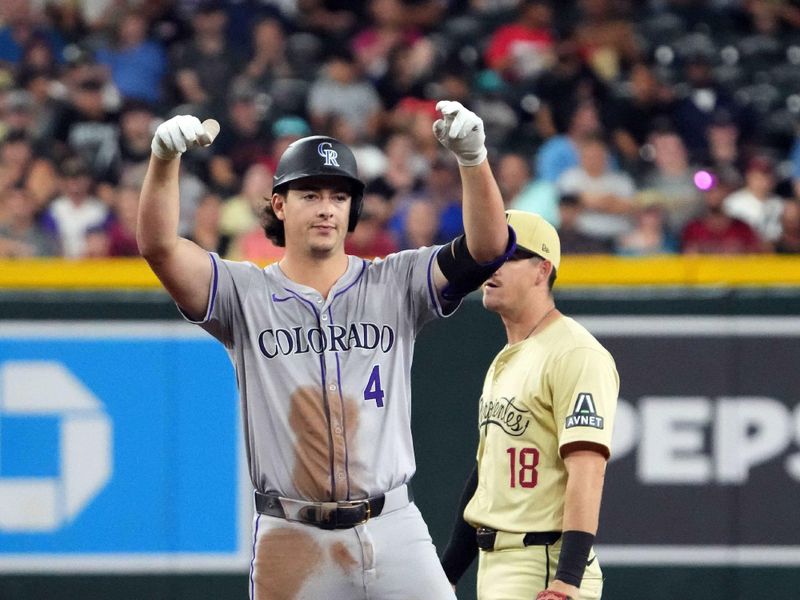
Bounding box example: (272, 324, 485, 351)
(184, 247, 455, 501)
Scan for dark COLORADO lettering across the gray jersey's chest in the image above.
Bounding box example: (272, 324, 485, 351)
(258, 323, 395, 358)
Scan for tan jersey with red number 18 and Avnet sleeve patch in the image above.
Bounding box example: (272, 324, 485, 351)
(464, 316, 619, 533)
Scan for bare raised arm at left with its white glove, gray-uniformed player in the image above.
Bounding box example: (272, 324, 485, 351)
(136, 115, 219, 319)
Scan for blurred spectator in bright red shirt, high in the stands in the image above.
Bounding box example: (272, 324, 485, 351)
(485, 0, 555, 81)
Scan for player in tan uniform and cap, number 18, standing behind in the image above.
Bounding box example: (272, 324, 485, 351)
(442, 210, 619, 600)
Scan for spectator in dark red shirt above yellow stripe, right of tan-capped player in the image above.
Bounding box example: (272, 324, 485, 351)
(681, 173, 765, 254)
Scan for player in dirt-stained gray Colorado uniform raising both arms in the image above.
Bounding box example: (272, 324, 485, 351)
(138, 101, 515, 600)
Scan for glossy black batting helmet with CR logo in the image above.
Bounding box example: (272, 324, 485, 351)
(272, 135, 364, 231)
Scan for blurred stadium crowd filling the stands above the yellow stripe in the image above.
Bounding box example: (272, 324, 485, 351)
(0, 0, 800, 261)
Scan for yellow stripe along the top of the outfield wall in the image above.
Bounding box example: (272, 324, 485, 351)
(0, 255, 800, 290)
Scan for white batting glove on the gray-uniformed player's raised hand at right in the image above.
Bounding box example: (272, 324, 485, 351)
(433, 100, 486, 167)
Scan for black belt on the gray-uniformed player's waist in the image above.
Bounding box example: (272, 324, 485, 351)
(255, 486, 413, 529)
